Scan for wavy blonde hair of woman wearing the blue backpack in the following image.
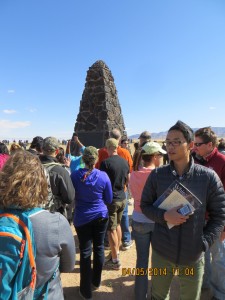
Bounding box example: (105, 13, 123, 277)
(0, 150, 48, 209)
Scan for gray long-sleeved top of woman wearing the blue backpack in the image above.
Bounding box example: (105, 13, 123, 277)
(30, 210, 76, 300)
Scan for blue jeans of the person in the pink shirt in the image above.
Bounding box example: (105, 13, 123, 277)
(132, 221, 155, 300)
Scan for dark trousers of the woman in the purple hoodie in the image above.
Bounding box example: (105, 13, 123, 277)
(75, 218, 108, 298)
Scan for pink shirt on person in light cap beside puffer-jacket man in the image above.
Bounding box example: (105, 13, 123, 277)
(129, 167, 153, 212)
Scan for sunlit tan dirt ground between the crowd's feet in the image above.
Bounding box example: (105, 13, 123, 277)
(61, 199, 211, 300)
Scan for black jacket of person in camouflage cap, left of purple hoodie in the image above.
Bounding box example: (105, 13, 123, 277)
(39, 155, 75, 204)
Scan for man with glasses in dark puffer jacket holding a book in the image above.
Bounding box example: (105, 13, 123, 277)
(141, 121, 225, 300)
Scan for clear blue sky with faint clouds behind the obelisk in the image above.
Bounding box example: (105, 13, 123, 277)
(0, 0, 225, 139)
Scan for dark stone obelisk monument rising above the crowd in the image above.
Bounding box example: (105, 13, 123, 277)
(74, 60, 125, 148)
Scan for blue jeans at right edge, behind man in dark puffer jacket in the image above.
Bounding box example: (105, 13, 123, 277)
(202, 239, 225, 300)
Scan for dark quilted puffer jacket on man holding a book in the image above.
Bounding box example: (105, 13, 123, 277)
(141, 159, 225, 265)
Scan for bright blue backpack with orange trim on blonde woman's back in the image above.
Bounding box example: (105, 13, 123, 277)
(0, 208, 56, 300)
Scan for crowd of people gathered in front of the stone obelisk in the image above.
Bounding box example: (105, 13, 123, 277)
(0, 121, 225, 300)
